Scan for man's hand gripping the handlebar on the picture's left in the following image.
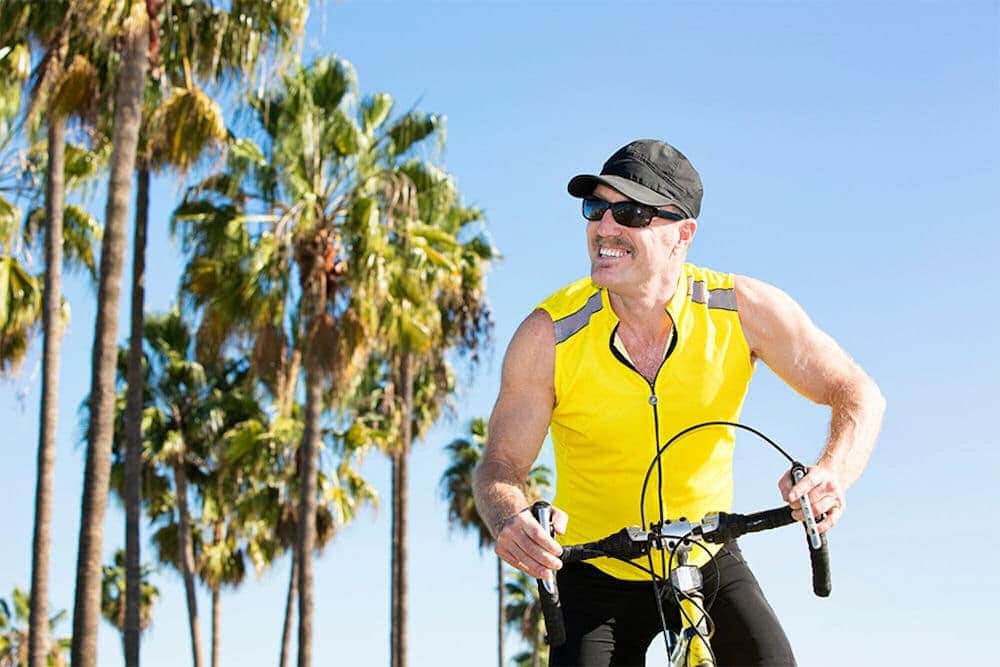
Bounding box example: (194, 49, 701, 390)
(494, 507, 569, 579)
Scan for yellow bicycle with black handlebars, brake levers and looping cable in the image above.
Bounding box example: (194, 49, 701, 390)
(531, 421, 831, 667)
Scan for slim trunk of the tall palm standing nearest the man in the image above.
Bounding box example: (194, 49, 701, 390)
(392, 352, 413, 667)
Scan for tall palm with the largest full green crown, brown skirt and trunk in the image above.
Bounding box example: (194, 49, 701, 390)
(176, 58, 450, 665)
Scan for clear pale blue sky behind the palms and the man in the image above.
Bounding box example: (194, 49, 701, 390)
(0, 0, 1000, 667)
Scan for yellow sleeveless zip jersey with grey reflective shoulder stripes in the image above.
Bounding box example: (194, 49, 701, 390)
(538, 264, 753, 581)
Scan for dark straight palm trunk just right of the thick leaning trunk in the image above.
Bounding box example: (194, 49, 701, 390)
(123, 167, 149, 667)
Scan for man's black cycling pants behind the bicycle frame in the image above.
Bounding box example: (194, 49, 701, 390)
(549, 542, 795, 667)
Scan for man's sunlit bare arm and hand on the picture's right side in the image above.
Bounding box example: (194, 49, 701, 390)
(735, 276, 885, 531)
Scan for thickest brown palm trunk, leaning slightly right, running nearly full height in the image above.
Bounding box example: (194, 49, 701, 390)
(71, 3, 149, 667)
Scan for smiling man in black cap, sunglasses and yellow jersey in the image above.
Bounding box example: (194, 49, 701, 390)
(475, 140, 885, 665)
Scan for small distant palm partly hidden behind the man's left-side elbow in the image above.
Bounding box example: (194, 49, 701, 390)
(440, 417, 552, 667)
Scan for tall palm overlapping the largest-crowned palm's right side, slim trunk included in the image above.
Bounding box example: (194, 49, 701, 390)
(368, 158, 496, 667)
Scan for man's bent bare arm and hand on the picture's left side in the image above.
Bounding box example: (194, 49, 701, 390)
(474, 310, 566, 577)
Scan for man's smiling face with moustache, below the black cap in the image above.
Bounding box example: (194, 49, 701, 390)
(587, 185, 697, 294)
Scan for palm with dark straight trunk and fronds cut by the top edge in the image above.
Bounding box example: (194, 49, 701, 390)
(117, 0, 308, 666)
